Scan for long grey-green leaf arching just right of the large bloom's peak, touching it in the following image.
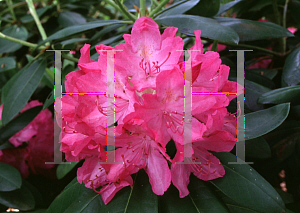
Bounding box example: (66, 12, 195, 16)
(156, 15, 239, 44)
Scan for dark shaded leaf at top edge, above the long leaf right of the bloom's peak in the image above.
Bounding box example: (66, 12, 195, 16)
(187, 0, 220, 17)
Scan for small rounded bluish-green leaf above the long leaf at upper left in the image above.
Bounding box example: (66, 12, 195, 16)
(57, 11, 86, 28)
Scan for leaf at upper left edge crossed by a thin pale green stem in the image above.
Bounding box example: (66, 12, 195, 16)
(0, 25, 28, 54)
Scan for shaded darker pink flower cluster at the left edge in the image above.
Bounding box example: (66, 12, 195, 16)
(0, 100, 56, 178)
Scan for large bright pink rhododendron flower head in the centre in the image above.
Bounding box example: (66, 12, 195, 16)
(57, 17, 242, 204)
